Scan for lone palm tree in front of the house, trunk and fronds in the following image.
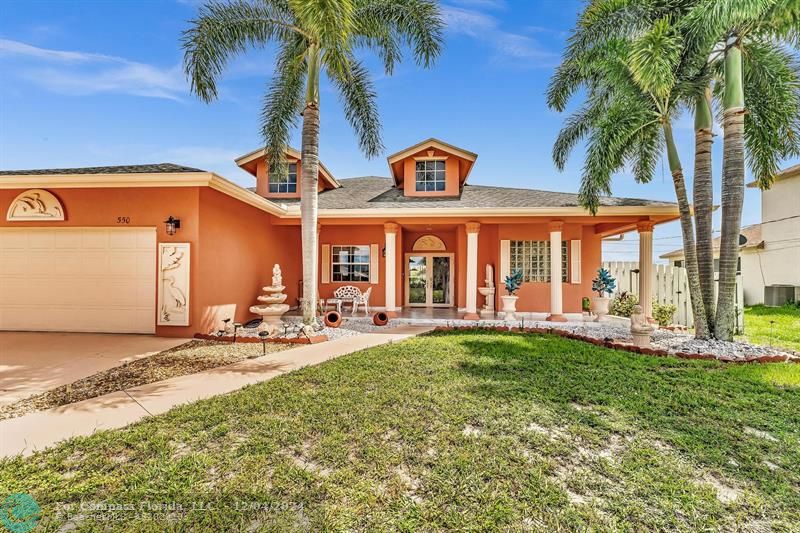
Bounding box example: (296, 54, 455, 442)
(183, 0, 443, 324)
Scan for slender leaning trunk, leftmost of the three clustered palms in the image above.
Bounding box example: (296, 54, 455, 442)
(664, 121, 708, 339)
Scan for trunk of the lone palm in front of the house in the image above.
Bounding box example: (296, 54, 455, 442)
(300, 45, 320, 324)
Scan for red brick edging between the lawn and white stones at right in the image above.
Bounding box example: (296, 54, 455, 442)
(434, 326, 800, 363)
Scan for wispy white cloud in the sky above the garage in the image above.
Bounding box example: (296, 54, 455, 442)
(0, 39, 186, 100)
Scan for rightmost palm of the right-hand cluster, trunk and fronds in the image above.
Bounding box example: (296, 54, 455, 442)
(686, 0, 800, 340)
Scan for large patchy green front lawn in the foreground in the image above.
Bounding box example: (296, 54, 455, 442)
(0, 332, 800, 531)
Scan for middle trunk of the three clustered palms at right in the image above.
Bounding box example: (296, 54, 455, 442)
(694, 88, 715, 336)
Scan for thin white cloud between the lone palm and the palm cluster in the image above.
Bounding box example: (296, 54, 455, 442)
(442, 6, 559, 67)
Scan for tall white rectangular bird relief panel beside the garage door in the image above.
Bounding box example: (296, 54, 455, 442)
(156, 242, 191, 326)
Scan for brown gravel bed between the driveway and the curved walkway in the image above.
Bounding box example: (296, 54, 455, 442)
(0, 340, 292, 420)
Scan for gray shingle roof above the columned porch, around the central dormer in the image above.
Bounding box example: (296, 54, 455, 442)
(275, 176, 675, 209)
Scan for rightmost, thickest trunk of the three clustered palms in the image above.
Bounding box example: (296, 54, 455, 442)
(716, 40, 744, 340)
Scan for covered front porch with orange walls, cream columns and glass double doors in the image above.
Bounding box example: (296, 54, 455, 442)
(310, 216, 655, 322)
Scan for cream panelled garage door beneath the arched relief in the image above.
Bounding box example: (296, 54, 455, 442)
(0, 228, 156, 333)
